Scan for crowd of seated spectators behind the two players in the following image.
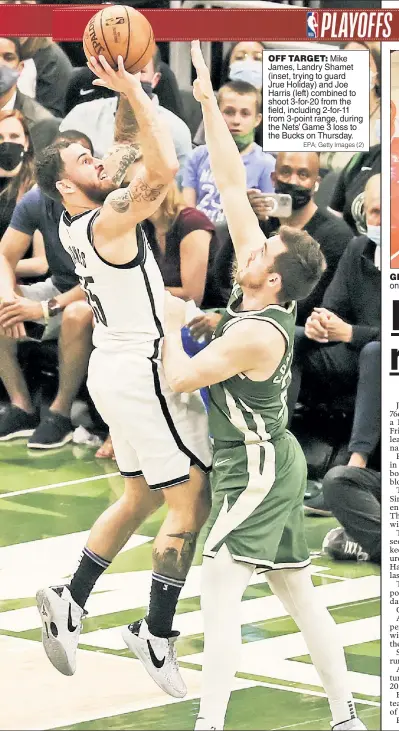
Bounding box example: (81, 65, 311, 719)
(0, 28, 381, 561)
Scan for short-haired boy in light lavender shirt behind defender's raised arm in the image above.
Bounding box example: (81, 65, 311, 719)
(183, 81, 275, 223)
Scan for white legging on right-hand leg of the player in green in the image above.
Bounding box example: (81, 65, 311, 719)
(266, 566, 356, 724)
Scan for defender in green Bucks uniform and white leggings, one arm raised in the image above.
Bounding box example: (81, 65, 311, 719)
(164, 41, 365, 731)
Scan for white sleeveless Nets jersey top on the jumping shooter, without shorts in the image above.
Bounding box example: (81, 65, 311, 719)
(59, 208, 165, 357)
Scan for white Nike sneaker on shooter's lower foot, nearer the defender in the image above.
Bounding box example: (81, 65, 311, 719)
(122, 619, 187, 698)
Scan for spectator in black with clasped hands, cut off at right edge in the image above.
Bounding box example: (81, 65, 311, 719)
(288, 175, 381, 504)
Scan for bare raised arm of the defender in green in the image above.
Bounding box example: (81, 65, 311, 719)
(191, 41, 265, 264)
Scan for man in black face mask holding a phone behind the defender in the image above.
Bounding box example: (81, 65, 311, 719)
(209, 152, 353, 318)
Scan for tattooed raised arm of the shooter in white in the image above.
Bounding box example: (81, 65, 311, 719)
(89, 56, 179, 231)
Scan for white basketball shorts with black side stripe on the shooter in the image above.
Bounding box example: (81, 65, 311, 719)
(87, 349, 212, 490)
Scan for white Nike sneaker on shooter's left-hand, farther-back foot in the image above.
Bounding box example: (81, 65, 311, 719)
(36, 586, 86, 675)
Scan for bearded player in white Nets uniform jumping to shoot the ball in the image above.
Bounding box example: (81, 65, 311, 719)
(37, 56, 211, 697)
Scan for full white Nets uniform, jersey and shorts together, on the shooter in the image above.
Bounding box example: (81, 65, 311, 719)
(60, 208, 212, 490)
